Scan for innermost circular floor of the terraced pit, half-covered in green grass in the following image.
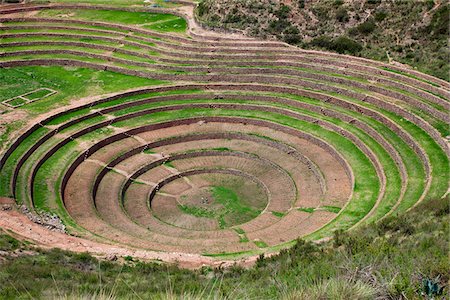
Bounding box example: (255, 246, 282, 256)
(151, 174, 269, 230)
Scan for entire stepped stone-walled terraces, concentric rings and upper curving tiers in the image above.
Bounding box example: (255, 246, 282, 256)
(0, 2, 450, 264)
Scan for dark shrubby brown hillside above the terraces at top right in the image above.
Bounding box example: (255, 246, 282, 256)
(196, 0, 450, 80)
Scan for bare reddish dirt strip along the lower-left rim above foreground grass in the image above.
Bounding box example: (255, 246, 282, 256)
(0, 206, 257, 269)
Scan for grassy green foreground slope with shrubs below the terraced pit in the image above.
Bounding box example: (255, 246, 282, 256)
(0, 199, 450, 299)
